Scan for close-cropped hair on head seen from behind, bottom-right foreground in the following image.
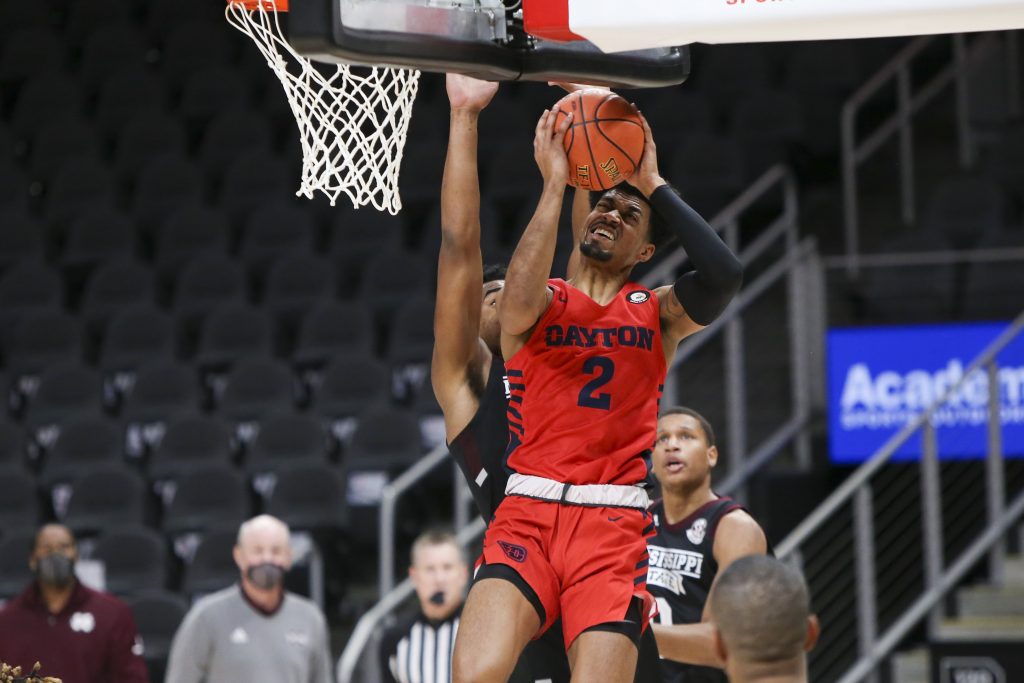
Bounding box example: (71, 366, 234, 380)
(709, 555, 811, 663)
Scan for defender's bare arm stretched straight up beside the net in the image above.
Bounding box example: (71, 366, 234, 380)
(431, 74, 498, 407)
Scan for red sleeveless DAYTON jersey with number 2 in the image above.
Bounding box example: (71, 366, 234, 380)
(505, 280, 666, 485)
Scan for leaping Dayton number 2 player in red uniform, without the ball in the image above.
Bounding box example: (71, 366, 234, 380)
(453, 98, 742, 682)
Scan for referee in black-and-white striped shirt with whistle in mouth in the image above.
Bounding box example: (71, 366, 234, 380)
(381, 531, 469, 683)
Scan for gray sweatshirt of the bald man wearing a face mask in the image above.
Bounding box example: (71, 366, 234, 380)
(165, 586, 332, 683)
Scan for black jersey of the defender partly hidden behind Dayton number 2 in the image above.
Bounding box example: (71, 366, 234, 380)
(449, 356, 509, 521)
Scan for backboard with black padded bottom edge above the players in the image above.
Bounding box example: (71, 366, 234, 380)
(287, 0, 689, 87)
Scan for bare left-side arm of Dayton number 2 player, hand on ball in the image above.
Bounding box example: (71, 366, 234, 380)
(498, 108, 572, 339)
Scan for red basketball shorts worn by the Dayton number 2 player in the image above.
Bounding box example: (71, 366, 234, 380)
(483, 496, 654, 649)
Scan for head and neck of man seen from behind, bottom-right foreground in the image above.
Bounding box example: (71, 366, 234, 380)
(710, 556, 819, 683)
